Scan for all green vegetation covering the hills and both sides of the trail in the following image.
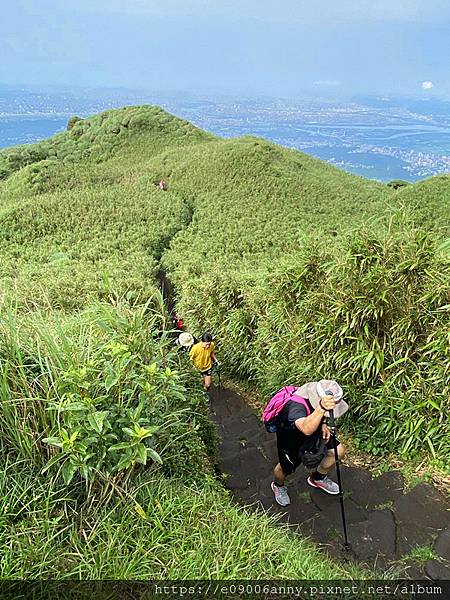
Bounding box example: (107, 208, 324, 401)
(0, 107, 450, 579)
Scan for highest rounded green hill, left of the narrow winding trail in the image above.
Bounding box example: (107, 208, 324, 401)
(0, 107, 211, 309)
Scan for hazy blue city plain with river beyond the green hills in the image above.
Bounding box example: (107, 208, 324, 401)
(0, 89, 450, 181)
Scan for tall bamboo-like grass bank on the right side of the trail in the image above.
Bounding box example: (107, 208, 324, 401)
(170, 215, 450, 464)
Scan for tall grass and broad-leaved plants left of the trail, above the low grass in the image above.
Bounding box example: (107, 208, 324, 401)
(0, 294, 213, 484)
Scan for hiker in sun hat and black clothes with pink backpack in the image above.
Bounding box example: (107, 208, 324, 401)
(263, 379, 348, 506)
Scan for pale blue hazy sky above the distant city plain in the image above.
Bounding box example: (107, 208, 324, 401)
(0, 0, 450, 98)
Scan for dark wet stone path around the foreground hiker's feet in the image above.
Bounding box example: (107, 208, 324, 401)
(210, 388, 450, 580)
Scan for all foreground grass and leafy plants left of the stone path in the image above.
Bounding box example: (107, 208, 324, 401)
(0, 295, 364, 579)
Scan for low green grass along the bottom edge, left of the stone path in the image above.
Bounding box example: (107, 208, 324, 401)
(0, 462, 367, 580)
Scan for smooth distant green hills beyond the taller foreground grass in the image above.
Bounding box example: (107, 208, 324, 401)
(0, 107, 398, 308)
